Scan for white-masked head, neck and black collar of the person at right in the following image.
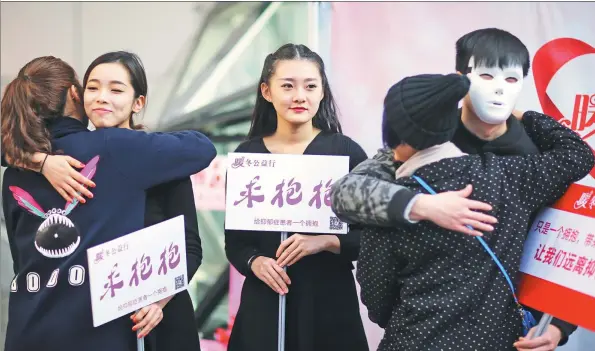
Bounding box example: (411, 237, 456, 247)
(453, 28, 538, 155)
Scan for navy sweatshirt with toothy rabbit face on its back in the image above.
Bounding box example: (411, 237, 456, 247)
(2, 118, 216, 351)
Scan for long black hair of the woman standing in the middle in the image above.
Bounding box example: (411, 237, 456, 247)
(248, 44, 343, 139)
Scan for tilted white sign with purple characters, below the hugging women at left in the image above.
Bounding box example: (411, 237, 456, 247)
(87, 215, 188, 327)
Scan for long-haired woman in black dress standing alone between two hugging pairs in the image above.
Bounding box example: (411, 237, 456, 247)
(225, 44, 368, 351)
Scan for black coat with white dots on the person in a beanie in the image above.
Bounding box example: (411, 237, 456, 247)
(356, 112, 594, 351)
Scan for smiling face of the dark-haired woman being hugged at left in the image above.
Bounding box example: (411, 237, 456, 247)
(83, 63, 145, 128)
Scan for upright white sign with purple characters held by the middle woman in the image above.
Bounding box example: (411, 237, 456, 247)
(225, 153, 349, 234)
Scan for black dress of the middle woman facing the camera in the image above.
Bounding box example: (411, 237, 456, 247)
(225, 132, 368, 351)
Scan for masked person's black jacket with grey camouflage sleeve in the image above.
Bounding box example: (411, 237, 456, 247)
(332, 116, 577, 346)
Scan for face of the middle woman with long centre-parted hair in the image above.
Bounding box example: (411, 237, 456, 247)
(261, 60, 324, 124)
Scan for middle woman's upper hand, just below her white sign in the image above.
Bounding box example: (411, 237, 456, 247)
(276, 234, 339, 267)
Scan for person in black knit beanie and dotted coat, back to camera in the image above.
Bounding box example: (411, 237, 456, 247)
(357, 73, 595, 351)
